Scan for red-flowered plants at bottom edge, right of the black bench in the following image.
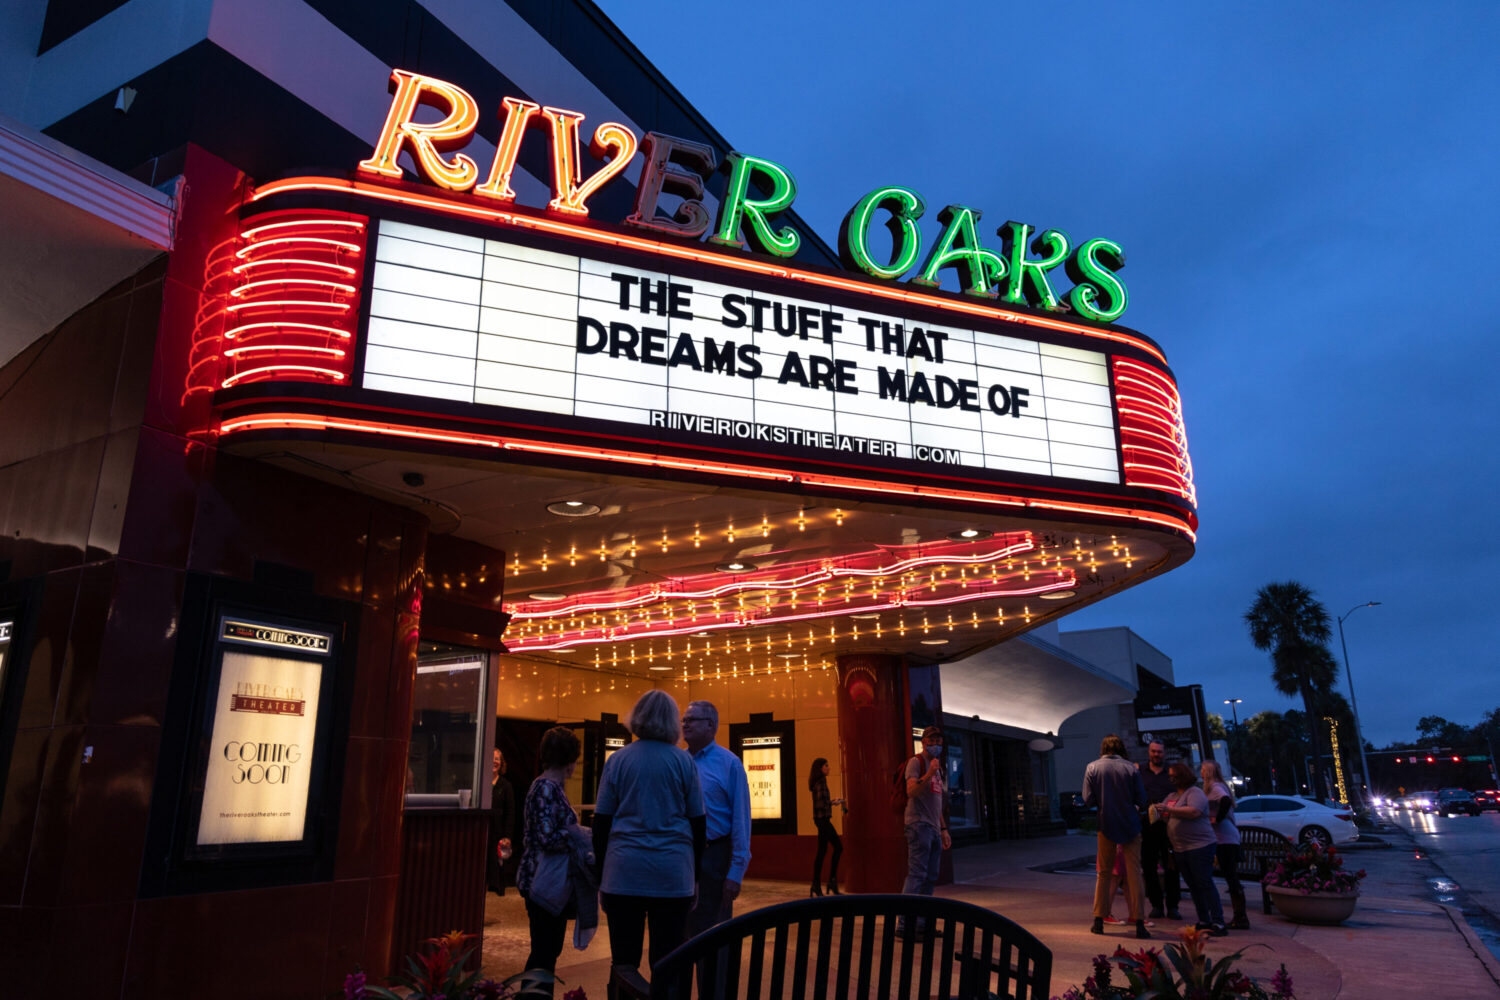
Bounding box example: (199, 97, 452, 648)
(1053, 927, 1296, 1000)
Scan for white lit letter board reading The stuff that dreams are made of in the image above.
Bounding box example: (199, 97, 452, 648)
(363, 220, 1119, 483)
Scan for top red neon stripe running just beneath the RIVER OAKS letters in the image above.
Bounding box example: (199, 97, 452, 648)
(251, 177, 1167, 364)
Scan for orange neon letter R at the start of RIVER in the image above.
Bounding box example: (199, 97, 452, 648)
(360, 69, 479, 190)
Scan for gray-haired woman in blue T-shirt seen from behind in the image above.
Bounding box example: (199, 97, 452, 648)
(594, 690, 705, 975)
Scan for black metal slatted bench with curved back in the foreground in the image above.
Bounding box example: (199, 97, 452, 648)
(651, 895, 1052, 1000)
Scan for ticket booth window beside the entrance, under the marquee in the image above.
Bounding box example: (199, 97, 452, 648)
(407, 640, 491, 808)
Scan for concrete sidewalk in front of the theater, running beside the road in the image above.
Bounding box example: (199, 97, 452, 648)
(483, 832, 1500, 1000)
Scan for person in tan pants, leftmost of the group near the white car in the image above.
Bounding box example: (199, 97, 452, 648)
(1083, 733, 1151, 939)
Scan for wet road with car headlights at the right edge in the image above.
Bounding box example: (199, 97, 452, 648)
(1382, 810, 1500, 957)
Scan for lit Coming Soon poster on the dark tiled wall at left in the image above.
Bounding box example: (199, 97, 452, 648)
(198, 621, 332, 846)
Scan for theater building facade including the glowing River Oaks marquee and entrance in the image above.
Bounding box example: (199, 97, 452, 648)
(0, 0, 1197, 996)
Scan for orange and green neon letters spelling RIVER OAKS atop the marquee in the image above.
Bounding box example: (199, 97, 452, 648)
(359, 69, 1128, 322)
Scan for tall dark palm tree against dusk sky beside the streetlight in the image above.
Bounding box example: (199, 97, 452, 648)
(1245, 580, 1338, 799)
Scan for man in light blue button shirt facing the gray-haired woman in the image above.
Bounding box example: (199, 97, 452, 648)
(683, 702, 750, 937)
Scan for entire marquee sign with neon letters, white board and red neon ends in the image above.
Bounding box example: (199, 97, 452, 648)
(219, 70, 1196, 537)
